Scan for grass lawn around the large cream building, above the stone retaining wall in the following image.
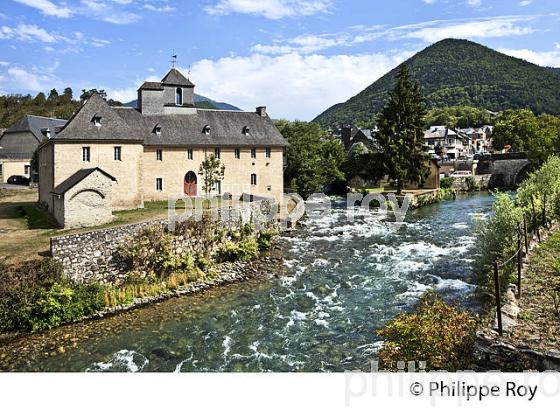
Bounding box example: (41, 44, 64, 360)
(0, 188, 229, 263)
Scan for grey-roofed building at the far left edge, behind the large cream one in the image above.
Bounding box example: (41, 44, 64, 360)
(0, 115, 66, 183)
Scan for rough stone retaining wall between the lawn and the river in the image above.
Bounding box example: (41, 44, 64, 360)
(51, 200, 275, 283)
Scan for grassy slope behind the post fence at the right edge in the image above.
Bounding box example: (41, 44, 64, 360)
(512, 231, 560, 351)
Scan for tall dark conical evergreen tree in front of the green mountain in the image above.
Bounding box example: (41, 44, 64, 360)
(378, 65, 429, 195)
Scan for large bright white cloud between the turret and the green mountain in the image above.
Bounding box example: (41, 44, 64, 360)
(171, 52, 412, 120)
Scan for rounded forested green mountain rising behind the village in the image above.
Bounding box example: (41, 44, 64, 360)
(313, 39, 560, 127)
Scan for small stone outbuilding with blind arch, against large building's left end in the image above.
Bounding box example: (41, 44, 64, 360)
(51, 168, 116, 229)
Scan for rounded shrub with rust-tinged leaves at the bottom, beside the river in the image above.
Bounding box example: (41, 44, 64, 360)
(378, 291, 476, 371)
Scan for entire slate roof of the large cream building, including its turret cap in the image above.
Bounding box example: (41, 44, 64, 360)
(50, 68, 288, 147)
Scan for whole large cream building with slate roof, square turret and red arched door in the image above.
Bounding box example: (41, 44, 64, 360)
(39, 68, 287, 227)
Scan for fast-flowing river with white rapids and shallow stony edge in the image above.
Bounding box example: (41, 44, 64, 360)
(0, 193, 493, 372)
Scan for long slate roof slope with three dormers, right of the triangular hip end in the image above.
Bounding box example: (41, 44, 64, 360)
(112, 107, 288, 147)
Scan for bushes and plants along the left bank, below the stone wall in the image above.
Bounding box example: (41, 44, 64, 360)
(0, 221, 278, 332)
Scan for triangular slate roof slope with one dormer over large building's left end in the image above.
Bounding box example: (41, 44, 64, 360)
(55, 93, 143, 141)
